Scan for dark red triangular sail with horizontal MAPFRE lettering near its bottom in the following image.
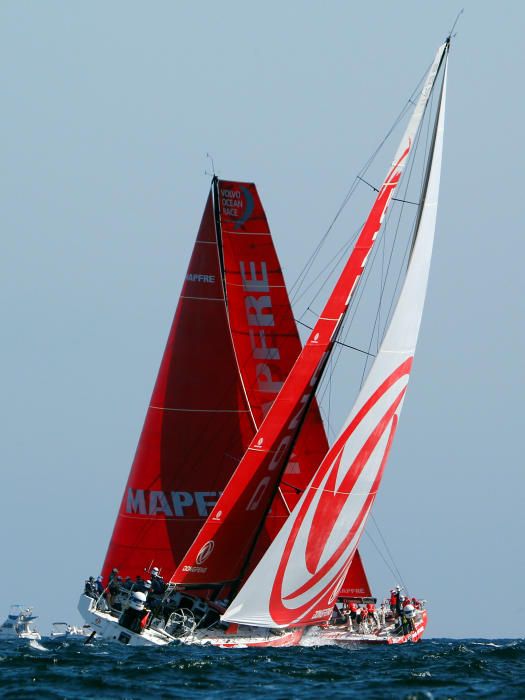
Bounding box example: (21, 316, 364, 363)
(103, 195, 254, 577)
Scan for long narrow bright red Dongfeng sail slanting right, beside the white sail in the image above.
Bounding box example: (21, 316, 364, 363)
(172, 149, 411, 586)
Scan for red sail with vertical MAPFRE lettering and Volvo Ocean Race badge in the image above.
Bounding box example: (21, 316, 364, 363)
(217, 180, 328, 566)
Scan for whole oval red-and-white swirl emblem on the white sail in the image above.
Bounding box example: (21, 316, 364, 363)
(269, 358, 412, 625)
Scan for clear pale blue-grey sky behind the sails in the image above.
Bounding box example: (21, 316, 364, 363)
(0, 0, 525, 637)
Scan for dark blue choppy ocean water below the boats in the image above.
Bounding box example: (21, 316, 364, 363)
(0, 638, 525, 700)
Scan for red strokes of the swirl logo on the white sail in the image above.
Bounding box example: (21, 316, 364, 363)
(269, 357, 413, 625)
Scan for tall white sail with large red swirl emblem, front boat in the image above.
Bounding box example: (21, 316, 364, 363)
(223, 50, 448, 627)
